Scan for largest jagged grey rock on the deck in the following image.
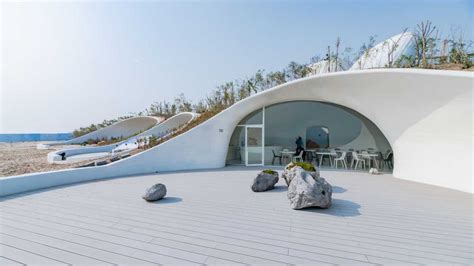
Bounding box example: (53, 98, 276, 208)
(287, 166, 332, 210)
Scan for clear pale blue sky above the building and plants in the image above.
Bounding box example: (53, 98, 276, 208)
(0, 0, 474, 133)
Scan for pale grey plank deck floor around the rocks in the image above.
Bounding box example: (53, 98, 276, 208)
(0, 167, 474, 265)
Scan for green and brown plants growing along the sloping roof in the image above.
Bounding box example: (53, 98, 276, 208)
(73, 21, 474, 137)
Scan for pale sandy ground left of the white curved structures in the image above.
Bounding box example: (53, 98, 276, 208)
(0, 142, 90, 178)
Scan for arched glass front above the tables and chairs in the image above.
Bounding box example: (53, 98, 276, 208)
(226, 100, 393, 169)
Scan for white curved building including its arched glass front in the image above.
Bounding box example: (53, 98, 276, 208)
(0, 69, 474, 195)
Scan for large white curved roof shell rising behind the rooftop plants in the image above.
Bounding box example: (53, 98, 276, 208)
(349, 32, 416, 70)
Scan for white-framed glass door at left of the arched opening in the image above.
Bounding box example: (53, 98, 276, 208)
(245, 125, 264, 166)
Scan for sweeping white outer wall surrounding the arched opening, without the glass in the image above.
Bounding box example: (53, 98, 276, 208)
(0, 69, 474, 195)
